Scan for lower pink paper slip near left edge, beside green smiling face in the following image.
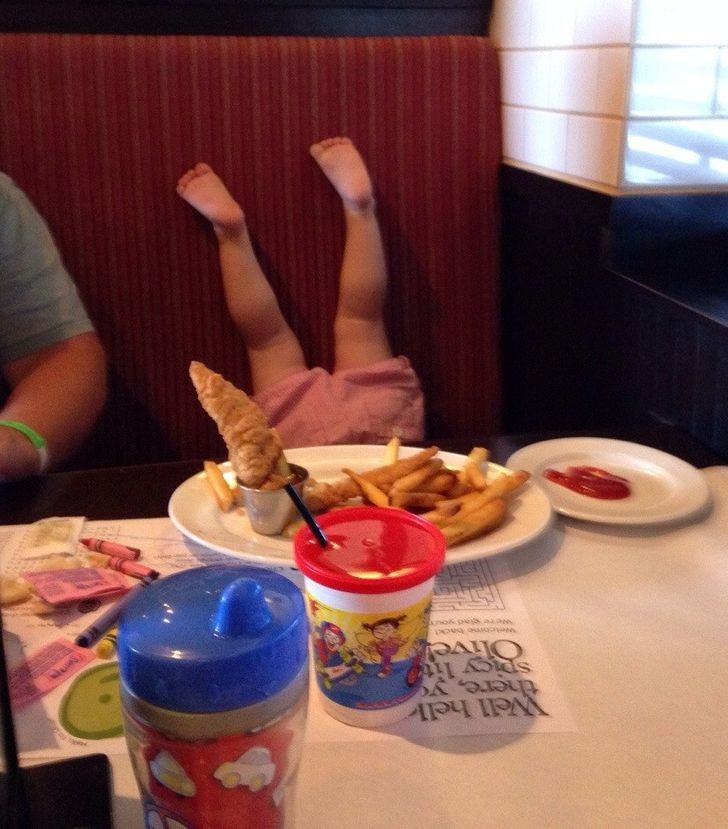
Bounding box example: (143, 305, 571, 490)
(8, 639, 95, 708)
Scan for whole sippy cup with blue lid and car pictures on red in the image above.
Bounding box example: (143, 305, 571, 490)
(118, 565, 308, 829)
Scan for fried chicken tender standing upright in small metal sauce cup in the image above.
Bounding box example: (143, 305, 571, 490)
(190, 361, 283, 488)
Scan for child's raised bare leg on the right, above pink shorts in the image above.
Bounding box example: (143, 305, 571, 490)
(311, 138, 392, 369)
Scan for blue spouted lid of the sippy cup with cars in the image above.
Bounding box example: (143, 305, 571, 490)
(117, 565, 308, 713)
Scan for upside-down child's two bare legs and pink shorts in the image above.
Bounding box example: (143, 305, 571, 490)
(177, 138, 423, 445)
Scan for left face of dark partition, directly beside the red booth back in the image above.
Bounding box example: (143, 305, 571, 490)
(501, 166, 612, 432)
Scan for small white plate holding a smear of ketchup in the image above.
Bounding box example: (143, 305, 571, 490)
(508, 437, 710, 525)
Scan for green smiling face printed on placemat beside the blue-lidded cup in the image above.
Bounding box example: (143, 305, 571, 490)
(59, 662, 124, 740)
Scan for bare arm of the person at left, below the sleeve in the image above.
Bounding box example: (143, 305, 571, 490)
(0, 332, 107, 481)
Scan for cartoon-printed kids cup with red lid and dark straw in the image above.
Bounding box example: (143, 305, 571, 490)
(293, 507, 445, 727)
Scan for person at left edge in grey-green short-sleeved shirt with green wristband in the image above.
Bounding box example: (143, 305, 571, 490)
(0, 173, 107, 481)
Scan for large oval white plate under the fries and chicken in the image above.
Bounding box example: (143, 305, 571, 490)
(169, 445, 552, 566)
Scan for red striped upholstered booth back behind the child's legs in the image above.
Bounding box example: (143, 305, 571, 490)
(0, 34, 501, 465)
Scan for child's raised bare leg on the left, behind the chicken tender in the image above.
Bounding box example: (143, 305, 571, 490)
(177, 164, 306, 393)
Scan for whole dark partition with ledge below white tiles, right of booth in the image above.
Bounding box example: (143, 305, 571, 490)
(501, 167, 728, 456)
